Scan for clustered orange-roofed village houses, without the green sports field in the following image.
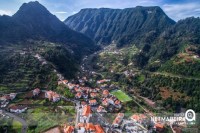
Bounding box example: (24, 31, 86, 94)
(0, 74, 172, 133)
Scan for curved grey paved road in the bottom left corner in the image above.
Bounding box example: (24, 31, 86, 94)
(2, 110, 28, 133)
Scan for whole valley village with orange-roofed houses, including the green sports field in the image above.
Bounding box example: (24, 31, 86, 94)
(0, 46, 185, 133)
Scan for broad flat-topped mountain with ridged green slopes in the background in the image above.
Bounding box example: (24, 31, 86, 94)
(64, 6, 175, 46)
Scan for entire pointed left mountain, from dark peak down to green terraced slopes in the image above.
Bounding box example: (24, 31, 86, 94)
(0, 1, 98, 93)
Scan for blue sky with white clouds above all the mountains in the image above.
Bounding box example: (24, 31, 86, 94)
(0, 0, 200, 21)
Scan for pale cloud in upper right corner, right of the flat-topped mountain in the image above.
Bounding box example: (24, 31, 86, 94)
(162, 2, 200, 21)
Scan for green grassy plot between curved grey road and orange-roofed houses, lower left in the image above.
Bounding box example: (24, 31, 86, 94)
(24, 106, 75, 133)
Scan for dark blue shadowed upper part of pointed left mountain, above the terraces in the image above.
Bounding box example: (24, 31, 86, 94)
(0, 1, 96, 55)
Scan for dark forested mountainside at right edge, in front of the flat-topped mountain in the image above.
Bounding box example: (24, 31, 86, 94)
(137, 17, 200, 70)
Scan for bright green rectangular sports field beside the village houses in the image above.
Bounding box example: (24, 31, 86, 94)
(111, 90, 132, 102)
